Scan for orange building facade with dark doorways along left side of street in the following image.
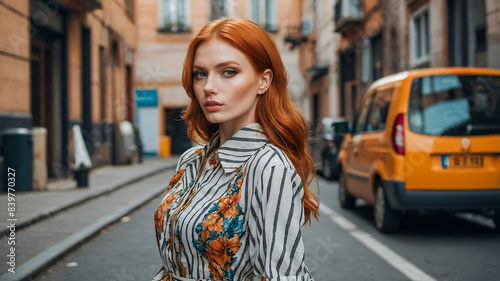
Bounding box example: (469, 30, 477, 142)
(0, 0, 137, 183)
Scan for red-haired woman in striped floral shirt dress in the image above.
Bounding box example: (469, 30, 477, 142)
(154, 19, 318, 281)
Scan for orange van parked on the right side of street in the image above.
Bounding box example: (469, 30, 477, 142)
(338, 68, 500, 232)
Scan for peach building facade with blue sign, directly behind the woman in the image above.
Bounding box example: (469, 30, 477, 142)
(135, 0, 307, 155)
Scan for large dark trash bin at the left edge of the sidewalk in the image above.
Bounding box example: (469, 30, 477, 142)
(2, 128, 33, 191)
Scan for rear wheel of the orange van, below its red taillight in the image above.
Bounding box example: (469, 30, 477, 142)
(373, 181, 399, 233)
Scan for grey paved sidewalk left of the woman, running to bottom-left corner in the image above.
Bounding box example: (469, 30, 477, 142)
(0, 157, 178, 281)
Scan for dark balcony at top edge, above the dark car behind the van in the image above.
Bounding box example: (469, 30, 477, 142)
(335, 0, 363, 33)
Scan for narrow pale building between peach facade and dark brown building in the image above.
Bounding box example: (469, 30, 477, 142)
(288, 0, 341, 127)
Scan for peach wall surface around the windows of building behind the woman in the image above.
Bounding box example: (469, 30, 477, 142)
(135, 0, 307, 150)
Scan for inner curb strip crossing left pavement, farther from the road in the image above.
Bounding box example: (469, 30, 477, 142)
(0, 160, 177, 238)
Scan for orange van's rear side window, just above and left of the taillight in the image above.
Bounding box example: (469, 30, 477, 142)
(366, 88, 394, 132)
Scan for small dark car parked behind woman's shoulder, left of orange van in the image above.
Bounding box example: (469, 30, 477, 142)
(311, 117, 348, 180)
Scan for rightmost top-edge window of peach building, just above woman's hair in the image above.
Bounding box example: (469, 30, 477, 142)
(250, 0, 278, 32)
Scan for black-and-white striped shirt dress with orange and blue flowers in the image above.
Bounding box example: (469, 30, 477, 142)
(154, 123, 313, 281)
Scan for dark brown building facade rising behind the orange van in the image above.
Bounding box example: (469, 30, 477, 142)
(335, 0, 500, 119)
